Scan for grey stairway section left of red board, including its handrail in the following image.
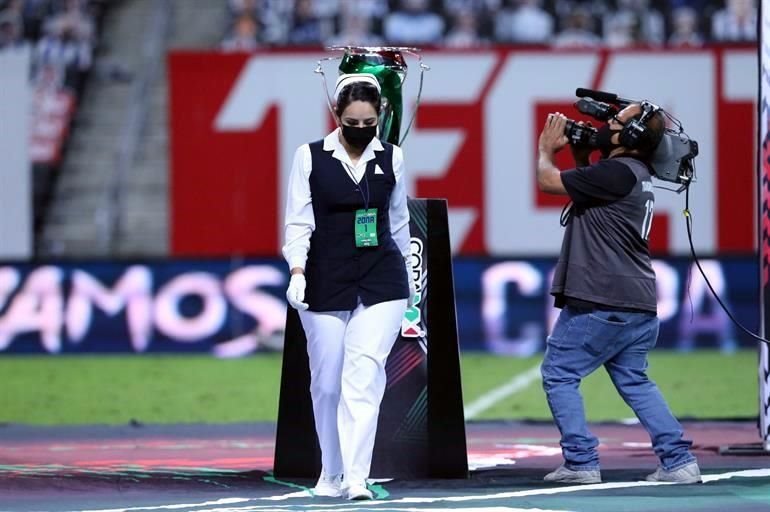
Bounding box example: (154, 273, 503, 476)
(39, 0, 225, 256)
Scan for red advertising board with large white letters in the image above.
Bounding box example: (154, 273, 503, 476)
(169, 47, 757, 256)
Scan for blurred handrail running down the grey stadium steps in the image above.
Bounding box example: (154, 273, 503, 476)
(95, 0, 173, 255)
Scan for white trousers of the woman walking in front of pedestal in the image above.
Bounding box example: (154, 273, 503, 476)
(299, 299, 407, 486)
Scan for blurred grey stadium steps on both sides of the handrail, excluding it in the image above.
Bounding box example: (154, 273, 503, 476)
(38, 0, 226, 257)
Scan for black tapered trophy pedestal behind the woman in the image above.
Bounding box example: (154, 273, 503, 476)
(274, 199, 468, 478)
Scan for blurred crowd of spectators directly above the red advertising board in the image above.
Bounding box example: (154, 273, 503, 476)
(221, 0, 757, 49)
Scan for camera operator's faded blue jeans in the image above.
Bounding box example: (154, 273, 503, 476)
(541, 306, 695, 471)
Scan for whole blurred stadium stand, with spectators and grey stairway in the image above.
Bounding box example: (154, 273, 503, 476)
(6, 0, 757, 257)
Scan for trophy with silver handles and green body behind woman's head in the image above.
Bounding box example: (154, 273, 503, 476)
(315, 46, 430, 146)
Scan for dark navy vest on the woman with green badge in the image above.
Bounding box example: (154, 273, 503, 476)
(305, 140, 409, 311)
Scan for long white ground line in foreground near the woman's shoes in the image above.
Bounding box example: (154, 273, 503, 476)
(73, 468, 770, 512)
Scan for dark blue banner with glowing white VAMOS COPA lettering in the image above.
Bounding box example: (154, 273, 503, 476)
(0, 256, 759, 357)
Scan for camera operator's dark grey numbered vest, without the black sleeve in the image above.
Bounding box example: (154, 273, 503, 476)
(551, 157, 658, 313)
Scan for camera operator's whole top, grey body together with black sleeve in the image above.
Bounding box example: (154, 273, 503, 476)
(551, 157, 657, 312)
